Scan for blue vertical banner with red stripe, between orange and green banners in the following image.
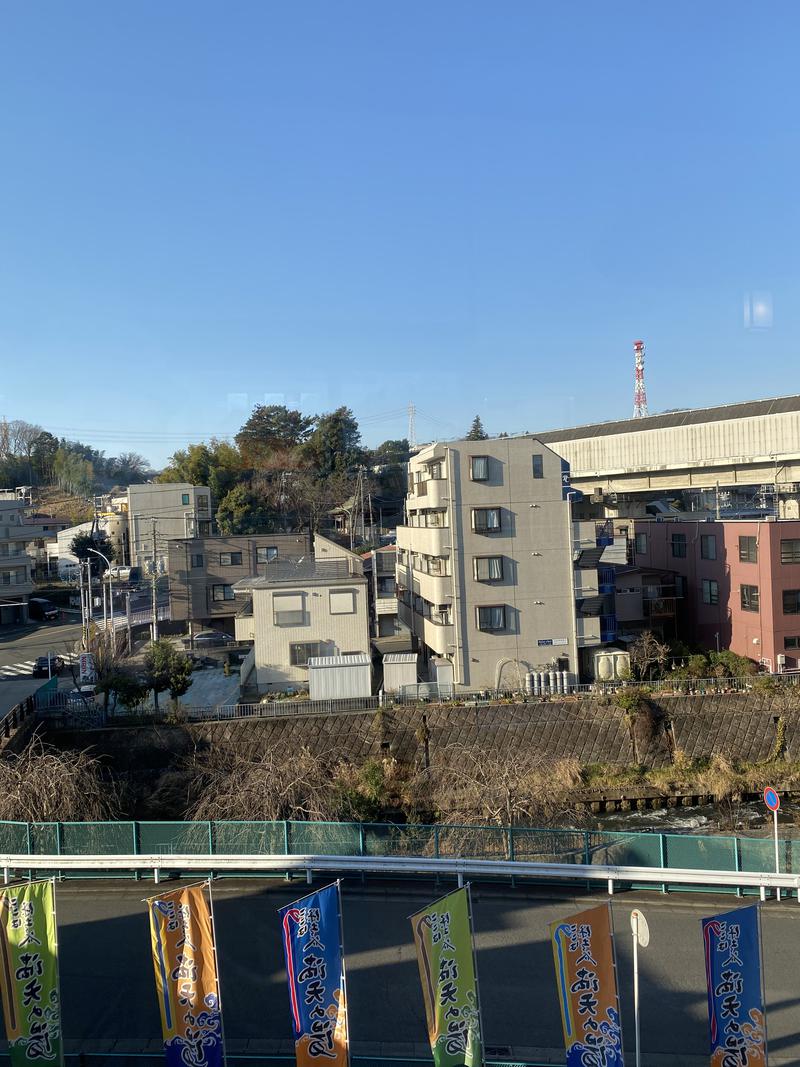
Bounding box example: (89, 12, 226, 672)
(278, 881, 350, 1067)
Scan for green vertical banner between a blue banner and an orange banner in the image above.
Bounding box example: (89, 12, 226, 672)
(411, 887, 483, 1067)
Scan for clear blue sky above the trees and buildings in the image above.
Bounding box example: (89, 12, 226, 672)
(0, 0, 800, 464)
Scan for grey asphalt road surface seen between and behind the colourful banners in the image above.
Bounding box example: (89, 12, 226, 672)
(26, 878, 800, 1067)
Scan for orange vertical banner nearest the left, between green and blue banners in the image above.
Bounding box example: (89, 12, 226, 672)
(145, 882, 225, 1067)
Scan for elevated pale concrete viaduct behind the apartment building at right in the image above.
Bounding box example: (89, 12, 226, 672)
(533, 396, 800, 493)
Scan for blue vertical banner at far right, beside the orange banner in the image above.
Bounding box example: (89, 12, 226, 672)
(703, 904, 767, 1067)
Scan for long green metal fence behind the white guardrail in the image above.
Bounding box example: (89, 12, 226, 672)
(0, 821, 800, 873)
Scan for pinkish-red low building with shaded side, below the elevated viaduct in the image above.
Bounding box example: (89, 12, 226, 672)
(631, 519, 800, 671)
